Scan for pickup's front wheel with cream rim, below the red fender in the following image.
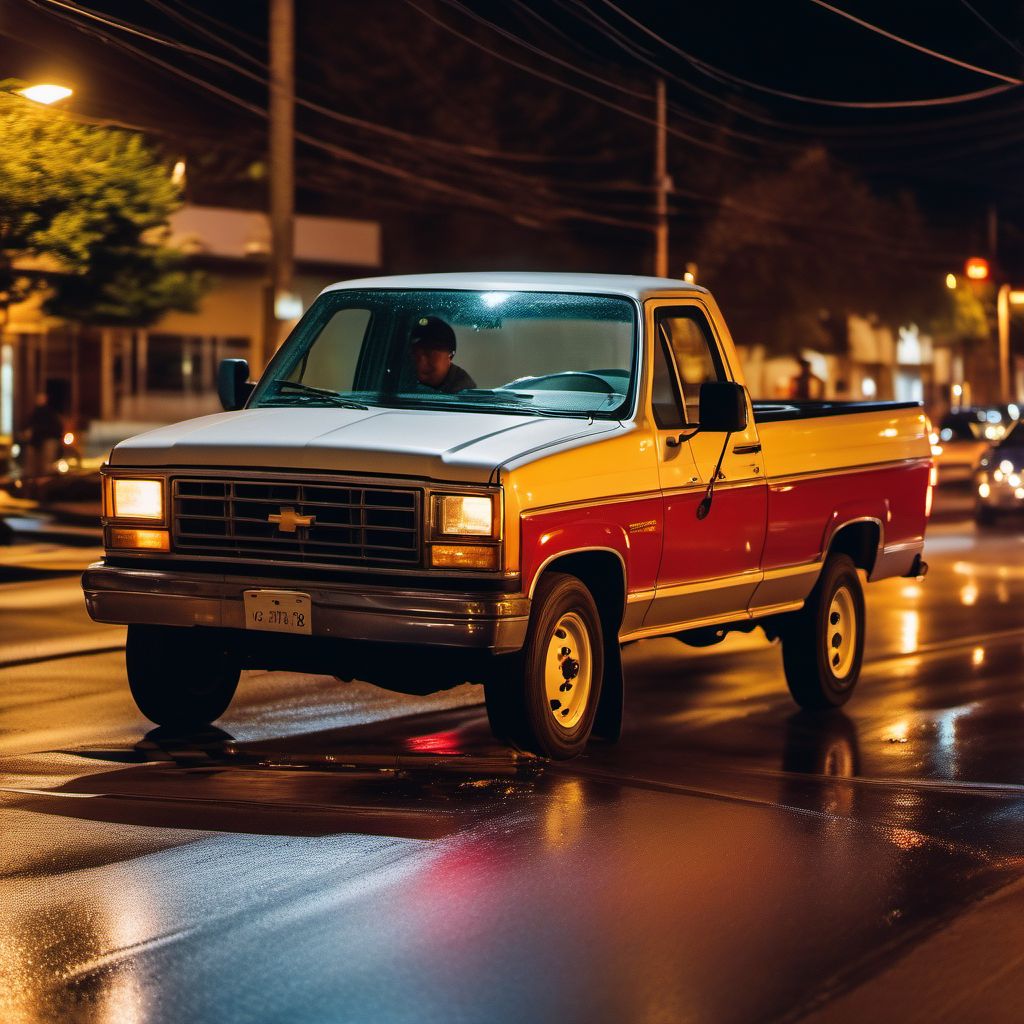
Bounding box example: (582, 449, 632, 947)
(483, 572, 604, 761)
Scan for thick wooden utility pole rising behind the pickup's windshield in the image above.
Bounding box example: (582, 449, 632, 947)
(263, 0, 295, 366)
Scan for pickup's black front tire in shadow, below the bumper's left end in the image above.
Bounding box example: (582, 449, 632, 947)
(125, 625, 241, 731)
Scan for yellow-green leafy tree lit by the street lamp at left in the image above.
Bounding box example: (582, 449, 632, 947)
(0, 91, 201, 326)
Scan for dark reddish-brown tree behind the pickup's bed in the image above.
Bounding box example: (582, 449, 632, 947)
(699, 148, 941, 354)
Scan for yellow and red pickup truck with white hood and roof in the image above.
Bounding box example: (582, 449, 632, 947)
(83, 273, 933, 758)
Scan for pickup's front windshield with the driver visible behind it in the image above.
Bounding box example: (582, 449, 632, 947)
(249, 289, 637, 418)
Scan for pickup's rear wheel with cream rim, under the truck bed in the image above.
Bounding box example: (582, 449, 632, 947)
(781, 555, 864, 711)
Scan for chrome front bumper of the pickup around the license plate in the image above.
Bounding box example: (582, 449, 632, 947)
(82, 562, 529, 654)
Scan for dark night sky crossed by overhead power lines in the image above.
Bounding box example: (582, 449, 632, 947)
(0, 0, 1024, 273)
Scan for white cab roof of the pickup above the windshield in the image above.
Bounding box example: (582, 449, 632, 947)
(324, 270, 708, 302)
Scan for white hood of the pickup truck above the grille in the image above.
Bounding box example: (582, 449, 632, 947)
(110, 408, 622, 483)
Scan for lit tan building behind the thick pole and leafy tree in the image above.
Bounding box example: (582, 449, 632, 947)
(0, 206, 382, 449)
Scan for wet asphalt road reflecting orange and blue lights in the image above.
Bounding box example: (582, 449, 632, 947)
(0, 497, 1024, 1024)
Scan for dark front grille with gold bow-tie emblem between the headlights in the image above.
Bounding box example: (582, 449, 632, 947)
(172, 478, 421, 566)
